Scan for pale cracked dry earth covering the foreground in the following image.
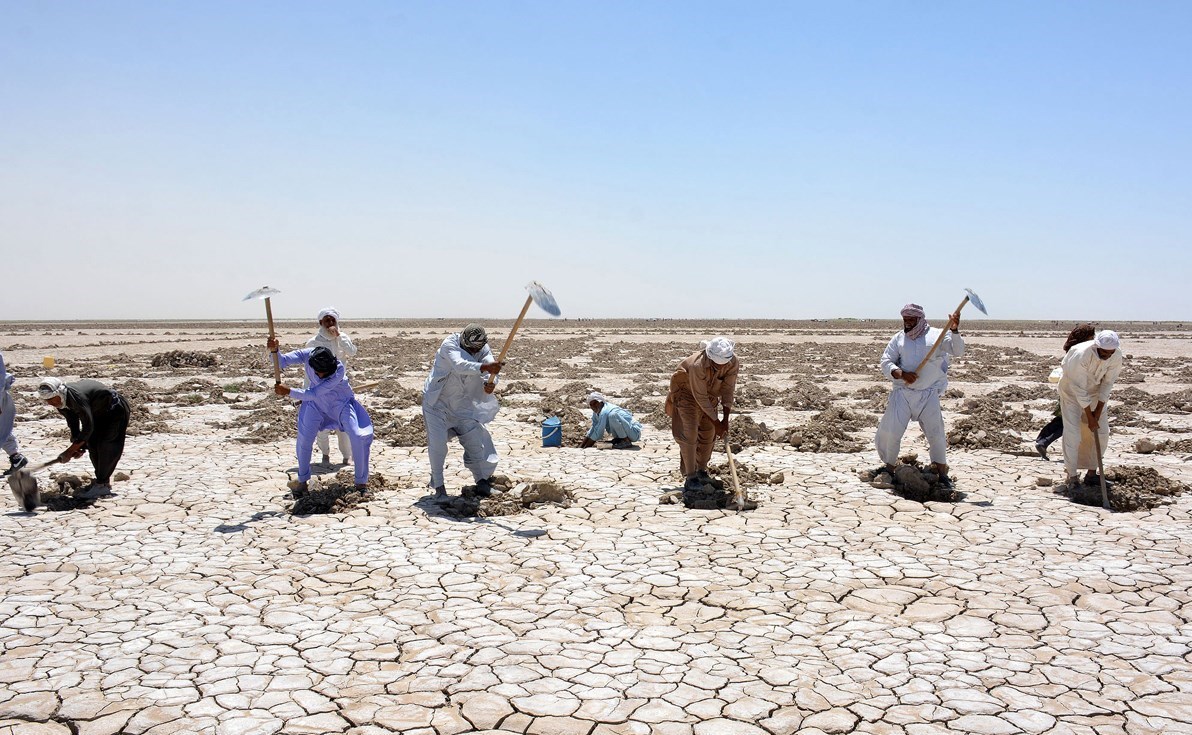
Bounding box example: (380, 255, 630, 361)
(0, 321, 1192, 735)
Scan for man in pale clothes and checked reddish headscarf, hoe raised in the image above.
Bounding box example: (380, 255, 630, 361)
(874, 304, 964, 488)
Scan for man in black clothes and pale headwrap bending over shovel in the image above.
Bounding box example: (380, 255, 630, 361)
(37, 378, 129, 498)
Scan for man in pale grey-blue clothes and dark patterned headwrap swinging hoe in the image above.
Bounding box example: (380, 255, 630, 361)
(422, 324, 501, 502)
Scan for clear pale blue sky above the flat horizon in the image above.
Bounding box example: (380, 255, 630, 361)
(0, 0, 1192, 320)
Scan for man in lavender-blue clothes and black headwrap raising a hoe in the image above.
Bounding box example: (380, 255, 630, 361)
(268, 337, 373, 498)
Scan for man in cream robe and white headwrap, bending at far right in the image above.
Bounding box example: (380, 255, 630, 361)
(1058, 330, 1122, 485)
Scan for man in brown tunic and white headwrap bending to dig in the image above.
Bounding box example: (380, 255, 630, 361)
(666, 337, 739, 491)
